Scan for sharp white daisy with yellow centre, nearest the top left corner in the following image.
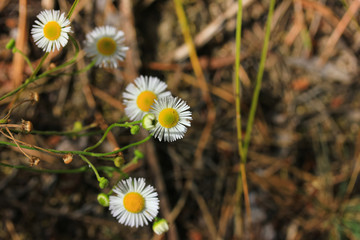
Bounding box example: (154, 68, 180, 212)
(31, 10, 71, 52)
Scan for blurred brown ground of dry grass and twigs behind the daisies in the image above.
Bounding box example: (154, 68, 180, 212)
(0, 0, 360, 240)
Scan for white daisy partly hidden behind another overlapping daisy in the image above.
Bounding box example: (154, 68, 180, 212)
(123, 76, 171, 121)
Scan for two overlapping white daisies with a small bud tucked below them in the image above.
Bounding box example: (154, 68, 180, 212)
(123, 76, 192, 142)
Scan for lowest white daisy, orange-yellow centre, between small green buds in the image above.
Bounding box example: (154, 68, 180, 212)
(109, 178, 159, 227)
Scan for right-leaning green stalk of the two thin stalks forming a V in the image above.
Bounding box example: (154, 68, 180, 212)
(242, 0, 275, 163)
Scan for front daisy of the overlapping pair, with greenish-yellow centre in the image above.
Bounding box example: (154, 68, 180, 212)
(149, 96, 192, 142)
